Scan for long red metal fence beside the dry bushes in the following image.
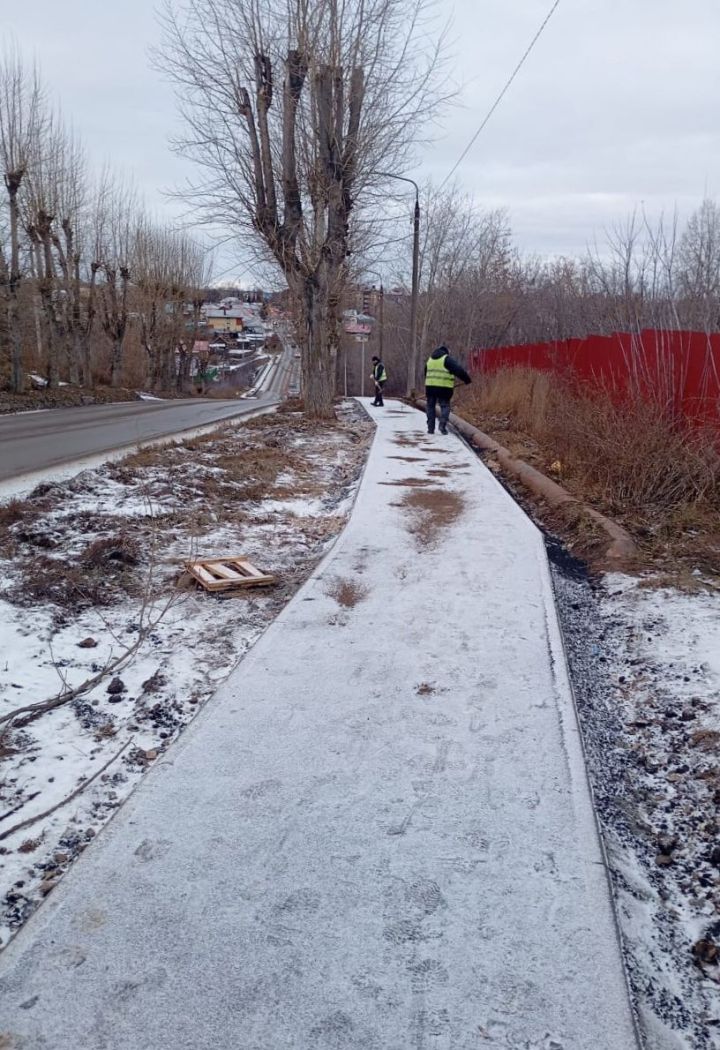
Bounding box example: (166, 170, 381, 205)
(470, 329, 720, 425)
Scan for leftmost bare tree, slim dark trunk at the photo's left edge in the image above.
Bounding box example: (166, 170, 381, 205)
(0, 49, 44, 393)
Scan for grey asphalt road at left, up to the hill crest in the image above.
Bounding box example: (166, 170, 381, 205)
(0, 393, 277, 481)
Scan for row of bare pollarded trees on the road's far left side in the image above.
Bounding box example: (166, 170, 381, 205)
(0, 49, 208, 393)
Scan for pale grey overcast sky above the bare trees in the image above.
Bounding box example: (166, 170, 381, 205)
(5, 0, 720, 279)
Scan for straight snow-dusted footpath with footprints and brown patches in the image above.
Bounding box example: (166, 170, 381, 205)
(0, 402, 636, 1050)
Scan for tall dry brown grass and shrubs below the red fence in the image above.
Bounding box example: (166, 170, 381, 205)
(458, 369, 720, 575)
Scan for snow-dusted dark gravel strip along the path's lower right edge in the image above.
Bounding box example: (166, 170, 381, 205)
(554, 569, 720, 1050)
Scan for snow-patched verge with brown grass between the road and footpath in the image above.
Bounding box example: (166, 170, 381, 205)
(0, 398, 372, 943)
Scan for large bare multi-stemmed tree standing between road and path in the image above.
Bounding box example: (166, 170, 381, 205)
(158, 0, 442, 417)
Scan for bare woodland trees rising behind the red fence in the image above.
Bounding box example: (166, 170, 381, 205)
(369, 186, 720, 390)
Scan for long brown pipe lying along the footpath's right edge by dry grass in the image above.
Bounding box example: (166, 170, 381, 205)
(416, 398, 640, 568)
